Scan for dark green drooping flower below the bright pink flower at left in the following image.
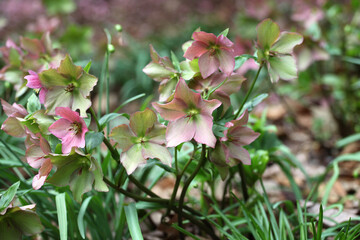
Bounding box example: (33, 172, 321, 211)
(47, 148, 109, 202)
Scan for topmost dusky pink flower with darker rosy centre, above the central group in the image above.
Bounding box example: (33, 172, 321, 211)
(184, 32, 235, 78)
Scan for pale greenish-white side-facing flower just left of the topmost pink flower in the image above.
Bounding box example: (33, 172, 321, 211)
(143, 45, 179, 102)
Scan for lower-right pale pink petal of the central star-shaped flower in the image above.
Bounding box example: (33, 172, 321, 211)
(194, 115, 216, 148)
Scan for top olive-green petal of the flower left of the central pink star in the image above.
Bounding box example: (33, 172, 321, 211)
(130, 108, 157, 137)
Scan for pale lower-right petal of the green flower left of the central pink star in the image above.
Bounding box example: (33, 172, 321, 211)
(142, 142, 172, 166)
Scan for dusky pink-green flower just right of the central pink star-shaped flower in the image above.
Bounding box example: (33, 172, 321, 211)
(210, 111, 260, 179)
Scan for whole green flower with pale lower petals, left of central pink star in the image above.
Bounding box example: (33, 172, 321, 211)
(110, 108, 171, 174)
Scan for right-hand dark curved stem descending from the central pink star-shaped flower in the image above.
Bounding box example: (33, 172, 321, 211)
(178, 144, 206, 239)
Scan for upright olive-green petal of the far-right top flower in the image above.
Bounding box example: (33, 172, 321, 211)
(257, 19, 280, 50)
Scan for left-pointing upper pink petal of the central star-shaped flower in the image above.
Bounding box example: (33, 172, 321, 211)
(152, 98, 187, 121)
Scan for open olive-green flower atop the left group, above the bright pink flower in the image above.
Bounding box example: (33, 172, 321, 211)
(39, 55, 97, 117)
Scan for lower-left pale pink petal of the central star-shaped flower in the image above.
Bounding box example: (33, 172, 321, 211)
(166, 117, 196, 147)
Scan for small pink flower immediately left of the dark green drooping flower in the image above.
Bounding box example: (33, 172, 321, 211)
(25, 134, 52, 190)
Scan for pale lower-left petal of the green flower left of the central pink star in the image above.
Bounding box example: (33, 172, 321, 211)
(120, 144, 146, 175)
